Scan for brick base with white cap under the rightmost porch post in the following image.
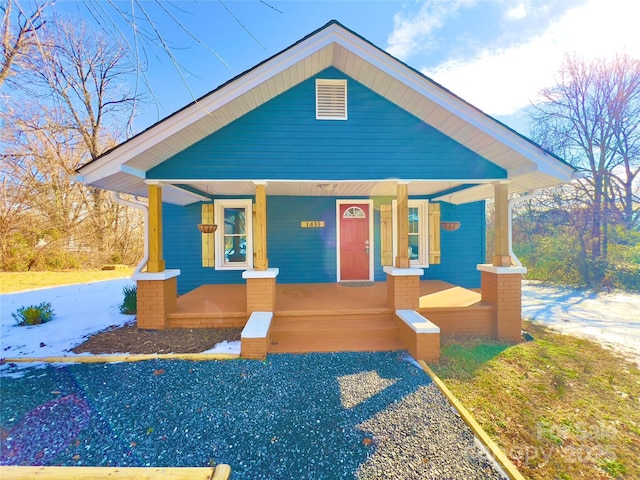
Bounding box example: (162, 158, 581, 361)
(478, 265, 527, 342)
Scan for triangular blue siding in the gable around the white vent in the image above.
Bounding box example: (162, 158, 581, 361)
(147, 68, 506, 184)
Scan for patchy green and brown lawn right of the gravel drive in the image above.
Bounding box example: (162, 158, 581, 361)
(433, 323, 640, 479)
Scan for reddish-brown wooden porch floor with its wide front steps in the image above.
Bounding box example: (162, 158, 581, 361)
(169, 281, 495, 353)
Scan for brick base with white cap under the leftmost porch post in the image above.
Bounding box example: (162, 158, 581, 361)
(132, 270, 180, 330)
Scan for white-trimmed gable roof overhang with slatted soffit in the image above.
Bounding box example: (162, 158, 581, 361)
(78, 21, 574, 205)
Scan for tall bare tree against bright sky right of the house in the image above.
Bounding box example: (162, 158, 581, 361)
(531, 56, 640, 283)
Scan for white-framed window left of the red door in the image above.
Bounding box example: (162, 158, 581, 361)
(215, 199, 253, 270)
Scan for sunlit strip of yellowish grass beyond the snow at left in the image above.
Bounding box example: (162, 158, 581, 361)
(0, 266, 133, 293)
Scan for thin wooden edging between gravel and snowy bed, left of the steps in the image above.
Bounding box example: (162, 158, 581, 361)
(1, 353, 240, 363)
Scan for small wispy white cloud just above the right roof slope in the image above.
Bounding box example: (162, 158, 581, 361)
(387, 0, 475, 60)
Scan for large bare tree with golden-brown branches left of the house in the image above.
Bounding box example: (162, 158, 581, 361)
(0, 16, 141, 267)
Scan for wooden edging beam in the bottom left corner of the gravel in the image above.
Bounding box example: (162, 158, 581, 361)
(0, 464, 231, 480)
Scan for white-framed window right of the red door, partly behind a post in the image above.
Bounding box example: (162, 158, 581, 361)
(393, 200, 429, 267)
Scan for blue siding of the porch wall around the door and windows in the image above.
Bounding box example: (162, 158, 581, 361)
(163, 196, 485, 294)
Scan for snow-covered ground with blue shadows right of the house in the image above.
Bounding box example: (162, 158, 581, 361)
(522, 281, 640, 366)
